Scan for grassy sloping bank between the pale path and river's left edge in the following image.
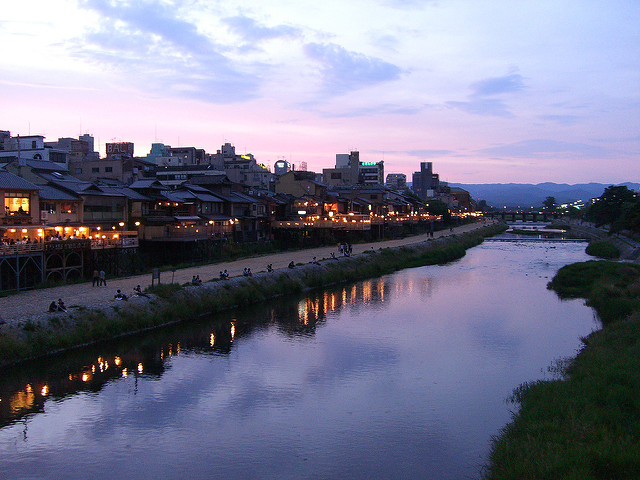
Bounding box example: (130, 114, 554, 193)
(0, 225, 506, 365)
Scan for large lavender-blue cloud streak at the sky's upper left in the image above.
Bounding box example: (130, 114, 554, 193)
(71, 0, 259, 103)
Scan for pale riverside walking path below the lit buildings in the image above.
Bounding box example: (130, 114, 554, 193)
(0, 221, 489, 326)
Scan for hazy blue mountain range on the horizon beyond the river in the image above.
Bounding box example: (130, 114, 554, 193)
(449, 182, 640, 208)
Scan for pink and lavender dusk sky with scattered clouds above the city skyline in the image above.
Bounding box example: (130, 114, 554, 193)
(0, 0, 640, 184)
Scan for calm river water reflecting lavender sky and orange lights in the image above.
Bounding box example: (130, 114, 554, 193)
(0, 241, 599, 480)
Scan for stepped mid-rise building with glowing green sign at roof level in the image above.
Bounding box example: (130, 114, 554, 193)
(322, 151, 384, 186)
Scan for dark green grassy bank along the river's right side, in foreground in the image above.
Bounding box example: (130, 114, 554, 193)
(485, 261, 640, 480)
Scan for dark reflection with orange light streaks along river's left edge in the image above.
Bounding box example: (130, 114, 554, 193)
(0, 277, 410, 425)
